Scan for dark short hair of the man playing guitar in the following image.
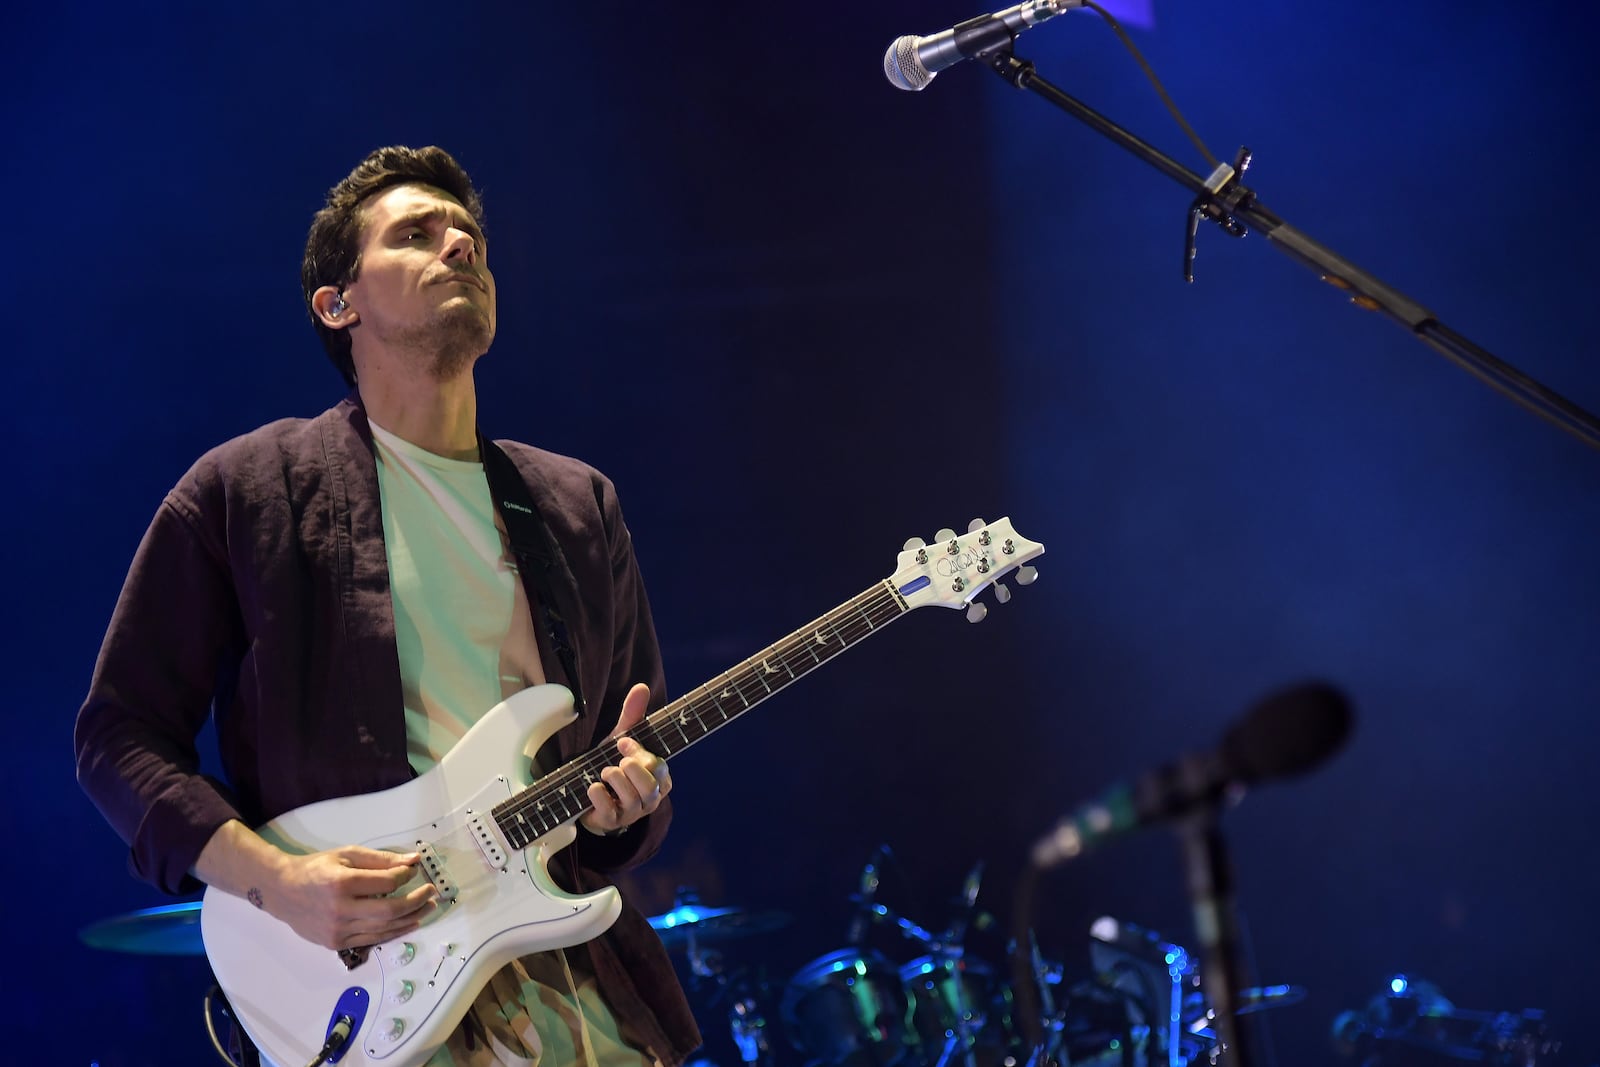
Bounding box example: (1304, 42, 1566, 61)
(301, 144, 483, 386)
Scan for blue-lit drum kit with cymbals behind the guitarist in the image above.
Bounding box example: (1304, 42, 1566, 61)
(80, 846, 1304, 1067)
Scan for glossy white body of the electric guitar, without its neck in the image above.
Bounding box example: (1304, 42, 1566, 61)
(200, 685, 622, 1067)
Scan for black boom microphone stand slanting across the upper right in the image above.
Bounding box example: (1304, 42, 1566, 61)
(978, 48, 1600, 450)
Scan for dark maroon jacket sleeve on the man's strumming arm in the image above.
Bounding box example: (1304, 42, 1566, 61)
(74, 491, 242, 893)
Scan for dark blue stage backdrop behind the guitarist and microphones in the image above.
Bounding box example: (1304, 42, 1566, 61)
(0, 0, 1600, 1067)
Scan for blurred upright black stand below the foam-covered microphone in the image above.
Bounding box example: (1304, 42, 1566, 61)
(1178, 805, 1253, 1067)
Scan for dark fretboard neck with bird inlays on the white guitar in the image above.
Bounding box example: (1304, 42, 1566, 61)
(493, 579, 910, 848)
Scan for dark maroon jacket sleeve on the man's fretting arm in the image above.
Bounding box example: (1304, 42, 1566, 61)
(576, 475, 672, 873)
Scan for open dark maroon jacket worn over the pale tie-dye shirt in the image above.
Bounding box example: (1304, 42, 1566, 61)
(75, 395, 699, 1067)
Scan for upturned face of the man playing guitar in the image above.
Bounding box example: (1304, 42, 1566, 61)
(346, 186, 494, 381)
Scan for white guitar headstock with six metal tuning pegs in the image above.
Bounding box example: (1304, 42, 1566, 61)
(890, 518, 1045, 622)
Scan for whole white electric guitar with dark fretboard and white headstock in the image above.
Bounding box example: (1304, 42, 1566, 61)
(200, 518, 1045, 1067)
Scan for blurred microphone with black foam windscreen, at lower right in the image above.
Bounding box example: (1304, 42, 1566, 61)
(1032, 681, 1350, 870)
